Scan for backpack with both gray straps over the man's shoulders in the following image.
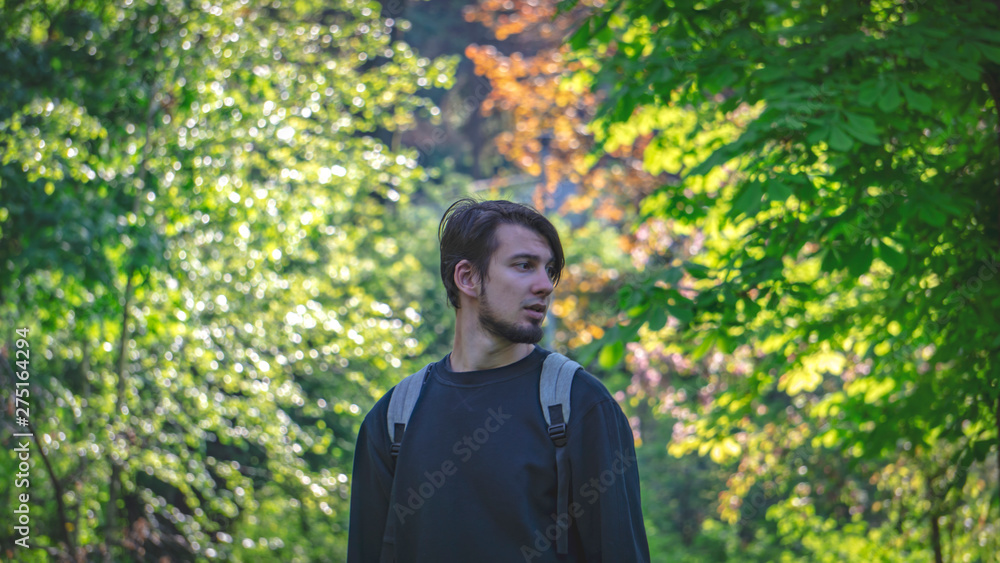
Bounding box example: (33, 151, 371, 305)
(383, 352, 580, 555)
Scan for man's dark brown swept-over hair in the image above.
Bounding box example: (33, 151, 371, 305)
(438, 198, 566, 309)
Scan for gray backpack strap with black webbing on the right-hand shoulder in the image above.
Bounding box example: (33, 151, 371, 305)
(538, 352, 580, 555)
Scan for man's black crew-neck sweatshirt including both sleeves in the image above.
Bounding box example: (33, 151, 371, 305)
(347, 347, 649, 563)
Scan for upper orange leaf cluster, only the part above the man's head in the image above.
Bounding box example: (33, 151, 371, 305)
(464, 0, 665, 224)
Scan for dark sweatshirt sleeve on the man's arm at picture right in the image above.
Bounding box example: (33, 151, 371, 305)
(568, 397, 650, 563)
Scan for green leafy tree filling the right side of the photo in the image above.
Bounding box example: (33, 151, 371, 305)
(566, 1, 1000, 561)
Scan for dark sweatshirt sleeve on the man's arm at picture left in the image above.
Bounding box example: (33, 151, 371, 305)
(347, 395, 392, 563)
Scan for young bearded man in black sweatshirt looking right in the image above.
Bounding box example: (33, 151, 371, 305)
(347, 200, 649, 563)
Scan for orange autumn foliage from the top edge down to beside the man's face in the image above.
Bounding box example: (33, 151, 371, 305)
(464, 0, 680, 356)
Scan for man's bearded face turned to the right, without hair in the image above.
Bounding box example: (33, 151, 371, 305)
(479, 225, 553, 344)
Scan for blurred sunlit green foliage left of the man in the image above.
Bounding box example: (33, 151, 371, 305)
(0, 0, 455, 561)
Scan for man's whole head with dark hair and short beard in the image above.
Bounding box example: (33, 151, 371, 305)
(438, 199, 565, 342)
